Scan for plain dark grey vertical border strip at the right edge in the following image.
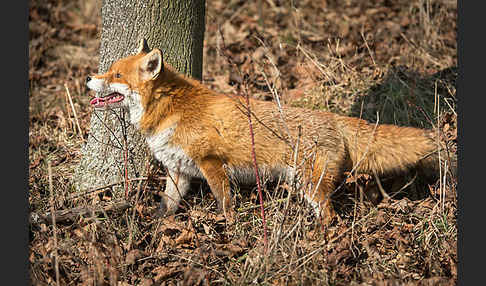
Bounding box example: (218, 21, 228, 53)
(456, 0, 478, 285)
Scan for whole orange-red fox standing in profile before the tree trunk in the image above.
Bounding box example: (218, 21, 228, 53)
(87, 39, 452, 224)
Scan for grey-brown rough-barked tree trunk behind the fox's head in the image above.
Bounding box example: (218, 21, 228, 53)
(73, 0, 205, 192)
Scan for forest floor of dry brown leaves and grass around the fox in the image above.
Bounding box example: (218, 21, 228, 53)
(29, 0, 458, 285)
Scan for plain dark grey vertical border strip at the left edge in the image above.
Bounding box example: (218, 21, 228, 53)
(6, 1, 30, 285)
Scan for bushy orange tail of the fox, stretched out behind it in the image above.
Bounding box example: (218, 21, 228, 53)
(338, 117, 455, 175)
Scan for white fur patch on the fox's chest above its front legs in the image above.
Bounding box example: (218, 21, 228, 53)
(146, 126, 203, 178)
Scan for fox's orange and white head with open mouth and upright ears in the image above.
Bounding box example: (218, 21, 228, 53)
(86, 39, 164, 113)
